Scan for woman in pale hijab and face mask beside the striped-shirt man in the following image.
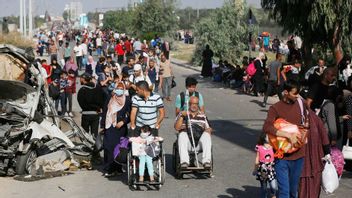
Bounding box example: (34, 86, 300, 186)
(103, 82, 131, 177)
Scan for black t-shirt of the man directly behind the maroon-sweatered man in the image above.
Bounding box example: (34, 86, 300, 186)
(307, 82, 329, 110)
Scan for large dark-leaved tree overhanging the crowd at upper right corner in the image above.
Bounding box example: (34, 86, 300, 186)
(262, 0, 352, 65)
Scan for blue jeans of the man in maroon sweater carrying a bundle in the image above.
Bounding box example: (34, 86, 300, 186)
(275, 158, 304, 198)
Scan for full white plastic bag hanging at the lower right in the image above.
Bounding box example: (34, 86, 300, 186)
(321, 161, 339, 194)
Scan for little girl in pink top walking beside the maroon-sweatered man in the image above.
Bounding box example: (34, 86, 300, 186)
(253, 133, 278, 198)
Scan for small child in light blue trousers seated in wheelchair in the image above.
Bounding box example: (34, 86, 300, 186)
(129, 125, 163, 182)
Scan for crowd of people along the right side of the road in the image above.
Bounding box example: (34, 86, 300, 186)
(202, 38, 352, 198)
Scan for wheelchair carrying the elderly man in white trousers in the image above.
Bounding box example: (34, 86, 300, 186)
(172, 139, 214, 179)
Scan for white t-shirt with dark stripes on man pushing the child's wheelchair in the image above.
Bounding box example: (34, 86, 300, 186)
(132, 93, 164, 128)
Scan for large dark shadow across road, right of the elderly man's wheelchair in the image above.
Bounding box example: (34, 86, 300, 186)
(210, 119, 262, 151)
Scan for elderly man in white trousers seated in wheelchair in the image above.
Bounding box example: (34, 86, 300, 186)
(175, 96, 212, 168)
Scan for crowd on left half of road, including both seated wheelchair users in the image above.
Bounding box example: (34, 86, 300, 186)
(37, 29, 211, 182)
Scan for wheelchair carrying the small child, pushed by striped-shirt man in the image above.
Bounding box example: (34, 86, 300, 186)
(127, 142, 166, 191)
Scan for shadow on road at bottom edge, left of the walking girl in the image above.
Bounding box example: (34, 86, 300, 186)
(218, 186, 260, 198)
